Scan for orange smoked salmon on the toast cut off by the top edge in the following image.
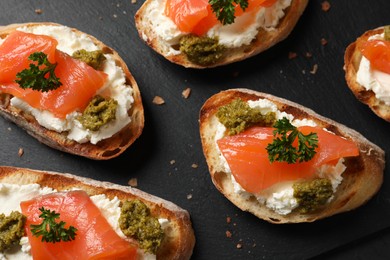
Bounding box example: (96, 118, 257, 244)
(164, 0, 277, 36)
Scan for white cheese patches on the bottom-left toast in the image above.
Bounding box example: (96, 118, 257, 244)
(0, 183, 169, 260)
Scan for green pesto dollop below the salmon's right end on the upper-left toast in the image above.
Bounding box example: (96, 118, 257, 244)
(77, 95, 118, 131)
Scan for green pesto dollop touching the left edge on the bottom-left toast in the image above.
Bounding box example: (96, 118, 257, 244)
(0, 211, 26, 252)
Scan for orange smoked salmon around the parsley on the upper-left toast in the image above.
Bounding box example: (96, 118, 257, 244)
(0, 31, 107, 118)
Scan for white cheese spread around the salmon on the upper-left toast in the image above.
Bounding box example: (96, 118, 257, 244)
(0, 25, 134, 144)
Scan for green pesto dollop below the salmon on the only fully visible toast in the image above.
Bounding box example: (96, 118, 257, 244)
(293, 178, 333, 213)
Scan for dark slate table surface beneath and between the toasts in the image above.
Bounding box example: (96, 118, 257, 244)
(0, 0, 390, 259)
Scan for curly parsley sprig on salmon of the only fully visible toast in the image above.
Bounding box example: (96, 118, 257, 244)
(266, 117, 318, 163)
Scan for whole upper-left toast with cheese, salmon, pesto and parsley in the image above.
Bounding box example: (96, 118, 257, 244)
(0, 23, 144, 160)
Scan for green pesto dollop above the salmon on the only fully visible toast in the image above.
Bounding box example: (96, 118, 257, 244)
(216, 98, 276, 135)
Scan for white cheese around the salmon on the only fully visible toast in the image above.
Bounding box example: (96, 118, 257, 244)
(215, 99, 346, 215)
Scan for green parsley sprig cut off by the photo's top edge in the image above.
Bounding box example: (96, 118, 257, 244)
(209, 0, 248, 25)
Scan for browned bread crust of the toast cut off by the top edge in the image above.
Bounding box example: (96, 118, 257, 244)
(135, 0, 308, 69)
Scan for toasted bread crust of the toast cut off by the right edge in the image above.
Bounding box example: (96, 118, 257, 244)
(344, 27, 390, 122)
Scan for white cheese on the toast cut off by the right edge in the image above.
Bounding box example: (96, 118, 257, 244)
(356, 34, 390, 106)
